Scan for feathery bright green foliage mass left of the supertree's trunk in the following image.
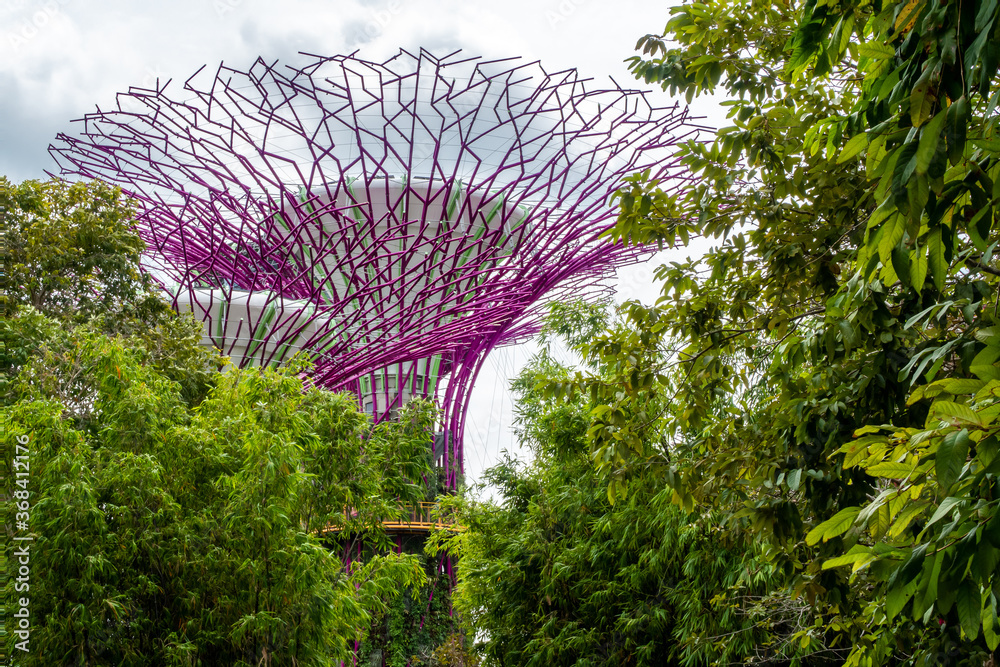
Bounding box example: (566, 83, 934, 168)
(0, 179, 435, 666)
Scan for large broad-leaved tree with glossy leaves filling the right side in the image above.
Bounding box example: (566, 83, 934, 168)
(548, 0, 1000, 665)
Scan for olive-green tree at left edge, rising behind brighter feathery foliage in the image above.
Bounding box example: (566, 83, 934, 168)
(0, 177, 221, 405)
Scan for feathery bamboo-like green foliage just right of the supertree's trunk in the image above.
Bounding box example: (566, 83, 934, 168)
(434, 306, 805, 666)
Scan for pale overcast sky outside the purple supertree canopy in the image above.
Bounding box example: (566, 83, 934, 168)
(0, 0, 716, 490)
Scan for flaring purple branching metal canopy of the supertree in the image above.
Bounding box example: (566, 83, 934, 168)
(50, 52, 696, 486)
